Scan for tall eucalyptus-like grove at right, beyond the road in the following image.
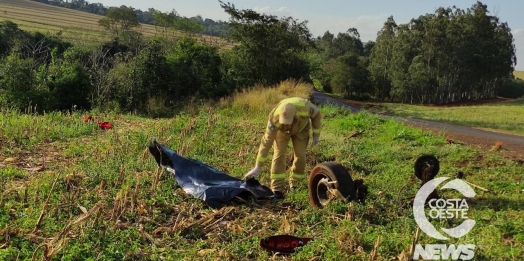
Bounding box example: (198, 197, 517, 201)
(311, 2, 524, 104)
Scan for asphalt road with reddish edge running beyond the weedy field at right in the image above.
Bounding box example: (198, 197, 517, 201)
(313, 91, 524, 160)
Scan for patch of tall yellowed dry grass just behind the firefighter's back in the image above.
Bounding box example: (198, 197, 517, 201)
(221, 80, 313, 112)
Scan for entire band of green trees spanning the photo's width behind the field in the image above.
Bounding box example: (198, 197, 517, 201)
(0, 2, 524, 116)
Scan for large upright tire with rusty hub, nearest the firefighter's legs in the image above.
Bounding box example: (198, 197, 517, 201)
(308, 161, 356, 208)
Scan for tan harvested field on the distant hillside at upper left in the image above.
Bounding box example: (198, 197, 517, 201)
(0, 0, 233, 48)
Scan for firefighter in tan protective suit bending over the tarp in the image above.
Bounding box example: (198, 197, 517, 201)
(244, 97, 322, 199)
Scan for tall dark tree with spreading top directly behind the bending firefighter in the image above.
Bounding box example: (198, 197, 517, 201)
(220, 2, 313, 86)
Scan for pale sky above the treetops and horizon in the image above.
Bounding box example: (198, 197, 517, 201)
(95, 0, 524, 71)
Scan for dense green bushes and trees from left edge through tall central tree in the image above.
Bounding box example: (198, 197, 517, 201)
(0, 1, 311, 116)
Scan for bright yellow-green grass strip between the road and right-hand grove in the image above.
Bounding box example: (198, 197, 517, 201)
(365, 98, 524, 135)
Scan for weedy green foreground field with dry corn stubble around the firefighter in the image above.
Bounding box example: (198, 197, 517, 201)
(0, 82, 524, 260)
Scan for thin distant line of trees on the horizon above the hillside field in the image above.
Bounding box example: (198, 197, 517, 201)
(33, 0, 231, 37)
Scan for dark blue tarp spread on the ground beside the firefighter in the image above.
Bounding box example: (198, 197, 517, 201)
(149, 139, 273, 208)
